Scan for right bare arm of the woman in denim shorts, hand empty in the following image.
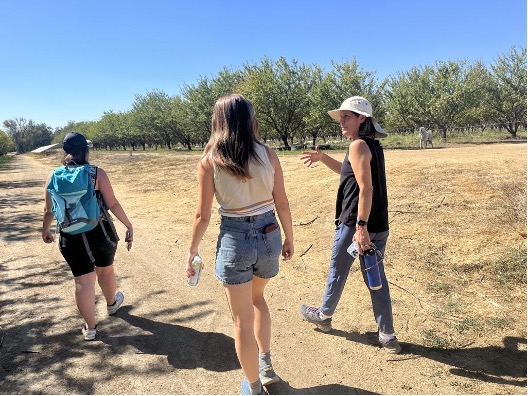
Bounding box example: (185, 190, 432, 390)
(268, 149, 294, 260)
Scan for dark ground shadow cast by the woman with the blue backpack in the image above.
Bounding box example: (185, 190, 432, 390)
(99, 306, 240, 372)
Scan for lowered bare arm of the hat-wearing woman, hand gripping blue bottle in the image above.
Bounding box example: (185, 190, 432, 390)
(348, 139, 373, 251)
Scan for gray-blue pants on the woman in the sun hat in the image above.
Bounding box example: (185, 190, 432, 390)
(321, 221, 394, 334)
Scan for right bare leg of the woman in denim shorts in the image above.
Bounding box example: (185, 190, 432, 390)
(253, 276, 271, 353)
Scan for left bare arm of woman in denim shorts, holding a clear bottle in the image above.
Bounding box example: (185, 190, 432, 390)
(187, 156, 214, 277)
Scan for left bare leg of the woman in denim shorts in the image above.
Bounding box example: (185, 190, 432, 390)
(224, 281, 259, 383)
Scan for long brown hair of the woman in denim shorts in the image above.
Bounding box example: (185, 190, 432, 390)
(204, 94, 260, 180)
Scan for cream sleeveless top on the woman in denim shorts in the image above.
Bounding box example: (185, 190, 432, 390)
(214, 143, 275, 217)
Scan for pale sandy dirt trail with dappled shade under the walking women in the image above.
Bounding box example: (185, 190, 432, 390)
(0, 150, 526, 394)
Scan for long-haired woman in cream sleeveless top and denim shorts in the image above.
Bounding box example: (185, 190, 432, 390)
(187, 94, 294, 394)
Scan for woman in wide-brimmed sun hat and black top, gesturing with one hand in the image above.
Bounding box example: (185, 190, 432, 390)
(300, 96, 401, 353)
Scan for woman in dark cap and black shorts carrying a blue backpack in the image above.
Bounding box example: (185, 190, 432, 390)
(42, 132, 133, 341)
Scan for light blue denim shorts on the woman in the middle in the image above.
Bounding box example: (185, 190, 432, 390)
(215, 211, 282, 285)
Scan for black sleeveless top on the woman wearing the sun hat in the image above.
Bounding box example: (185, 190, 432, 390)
(335, 137, 389, 232)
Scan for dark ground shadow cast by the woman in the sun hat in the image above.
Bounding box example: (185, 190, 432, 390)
(330, 329, 527, 386)
